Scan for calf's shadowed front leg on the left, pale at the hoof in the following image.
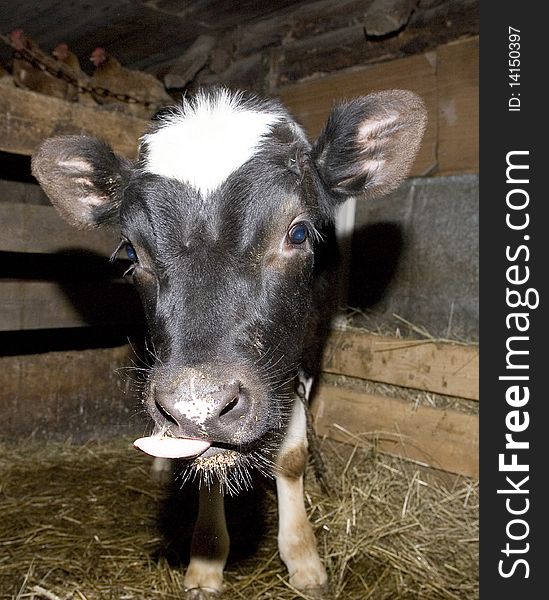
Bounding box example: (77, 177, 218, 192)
(184, 485, 229, 600)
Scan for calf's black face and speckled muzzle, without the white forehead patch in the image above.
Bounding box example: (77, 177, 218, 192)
(115, 125, 324, 486)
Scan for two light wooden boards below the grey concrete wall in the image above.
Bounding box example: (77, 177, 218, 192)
(312, 330, 479, 477)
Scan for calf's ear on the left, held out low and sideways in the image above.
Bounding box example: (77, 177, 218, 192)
(32, 135, 132, 229)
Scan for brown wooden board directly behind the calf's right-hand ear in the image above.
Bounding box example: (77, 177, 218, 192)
(278, 53, 437, 175)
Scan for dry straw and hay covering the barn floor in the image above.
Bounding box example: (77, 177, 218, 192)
(0, 441, 478, 600)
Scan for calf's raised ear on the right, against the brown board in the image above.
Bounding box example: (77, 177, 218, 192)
(312, 90, 427, 200)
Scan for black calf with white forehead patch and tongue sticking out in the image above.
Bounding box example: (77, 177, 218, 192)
(32, 89, 426, 598)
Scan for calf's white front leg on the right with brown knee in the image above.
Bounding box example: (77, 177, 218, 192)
(276, 382, 328, 594)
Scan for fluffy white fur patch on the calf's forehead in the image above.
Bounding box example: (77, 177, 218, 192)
(141, 89, 281, 195)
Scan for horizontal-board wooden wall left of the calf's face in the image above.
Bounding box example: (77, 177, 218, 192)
(0, 84, 146, 441)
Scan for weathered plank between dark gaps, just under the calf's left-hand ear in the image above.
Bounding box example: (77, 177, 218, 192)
(0, 202, 118, 256)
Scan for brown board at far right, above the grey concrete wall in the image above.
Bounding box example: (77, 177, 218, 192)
(437, 38, 479, 173)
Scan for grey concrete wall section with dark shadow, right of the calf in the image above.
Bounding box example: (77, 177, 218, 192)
(348, 174, 479, 341)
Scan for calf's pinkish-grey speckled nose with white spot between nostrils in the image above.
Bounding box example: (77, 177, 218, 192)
(154, 377, 252, 444)
